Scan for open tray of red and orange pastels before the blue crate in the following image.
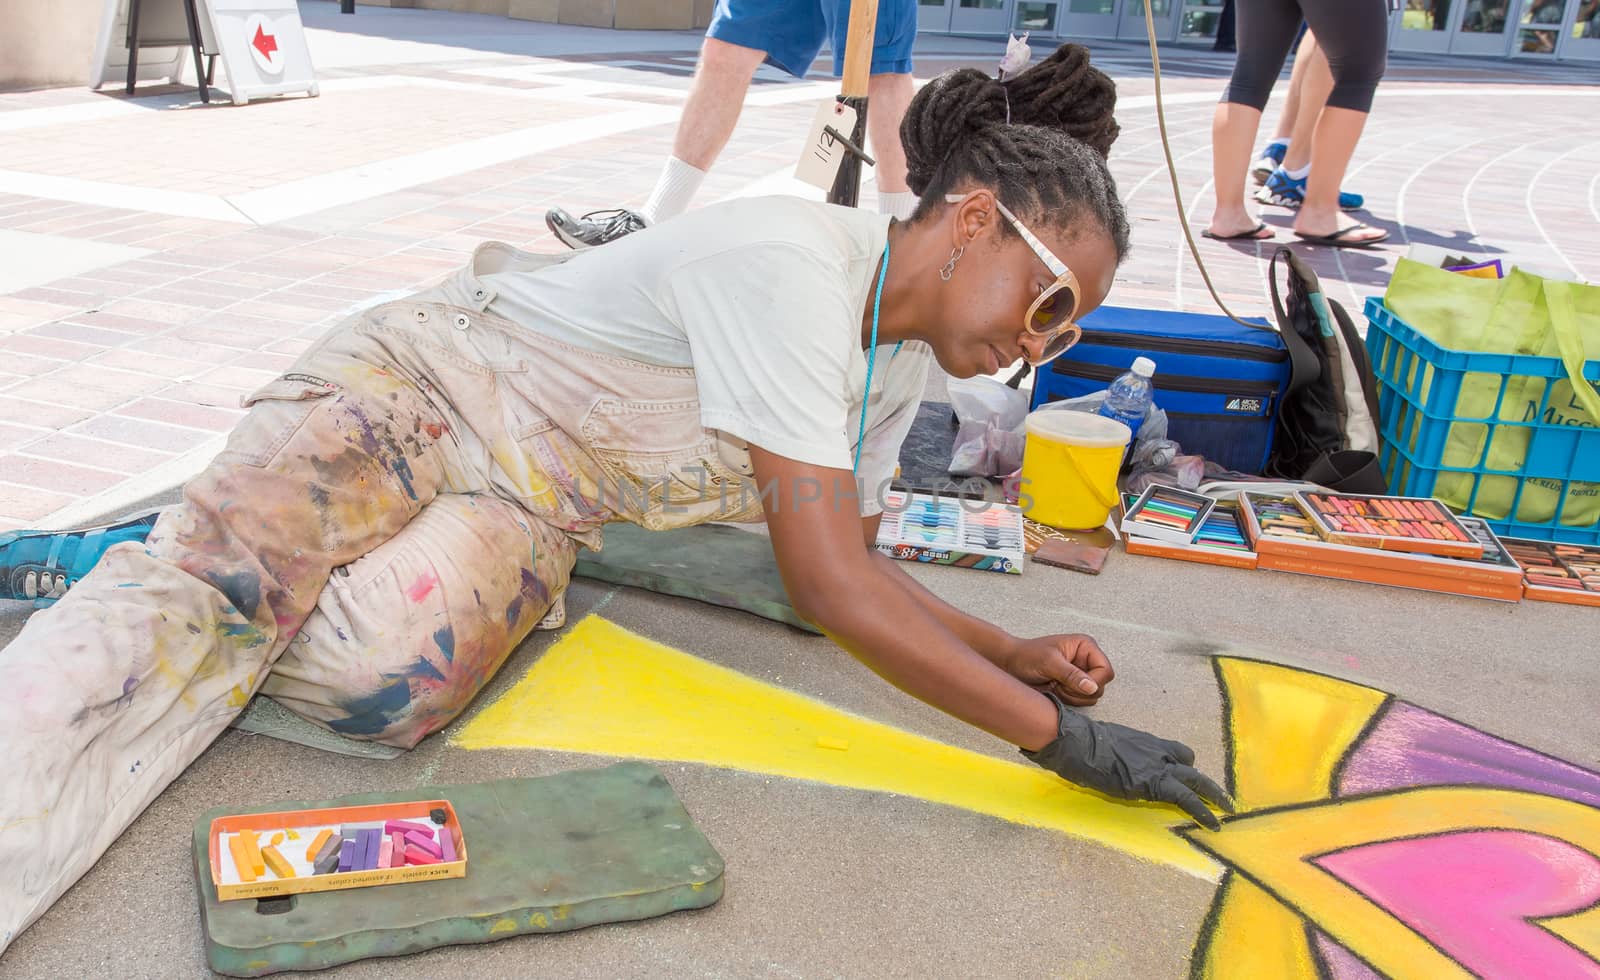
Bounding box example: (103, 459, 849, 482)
(1294, 493, 1483, 559)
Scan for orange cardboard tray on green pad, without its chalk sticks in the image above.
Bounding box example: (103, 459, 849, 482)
(208, 799, 467, 902)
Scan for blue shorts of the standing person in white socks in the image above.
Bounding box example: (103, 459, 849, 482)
(706, 0, 917, 78)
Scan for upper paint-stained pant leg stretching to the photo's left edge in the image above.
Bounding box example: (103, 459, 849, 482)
(0, 359, 453, 951)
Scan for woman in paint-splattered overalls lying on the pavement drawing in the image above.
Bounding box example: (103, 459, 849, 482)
(0, 46, 1229, 950)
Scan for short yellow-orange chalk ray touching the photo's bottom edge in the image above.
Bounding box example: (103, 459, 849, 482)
(1190, 874, 1318, 980)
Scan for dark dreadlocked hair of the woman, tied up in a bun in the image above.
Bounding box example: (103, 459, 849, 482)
(901, 45, 1128, 261)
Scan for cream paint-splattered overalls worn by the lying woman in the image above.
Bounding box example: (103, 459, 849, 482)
(0, 243, 762, 951)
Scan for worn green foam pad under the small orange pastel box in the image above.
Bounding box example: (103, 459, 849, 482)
(194, 762, 723, 977)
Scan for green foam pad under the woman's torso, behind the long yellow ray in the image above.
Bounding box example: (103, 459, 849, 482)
(573, 524, 818, 633)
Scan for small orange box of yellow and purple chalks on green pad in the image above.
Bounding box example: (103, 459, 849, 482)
(211, 799, 467, 902)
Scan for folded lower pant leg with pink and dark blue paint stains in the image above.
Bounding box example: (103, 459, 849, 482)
(261, 493, 578, 748)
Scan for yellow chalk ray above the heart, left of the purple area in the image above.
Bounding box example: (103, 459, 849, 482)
(1216, 657, 1389, 810)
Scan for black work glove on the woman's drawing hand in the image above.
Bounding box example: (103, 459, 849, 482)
(1022, 692, 1234, 829)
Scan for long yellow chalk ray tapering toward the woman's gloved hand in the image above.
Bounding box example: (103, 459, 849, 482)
(453, 617, 1219, 881)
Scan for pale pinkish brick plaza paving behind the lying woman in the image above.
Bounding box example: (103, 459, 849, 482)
(0, 2, 1600, 530)
